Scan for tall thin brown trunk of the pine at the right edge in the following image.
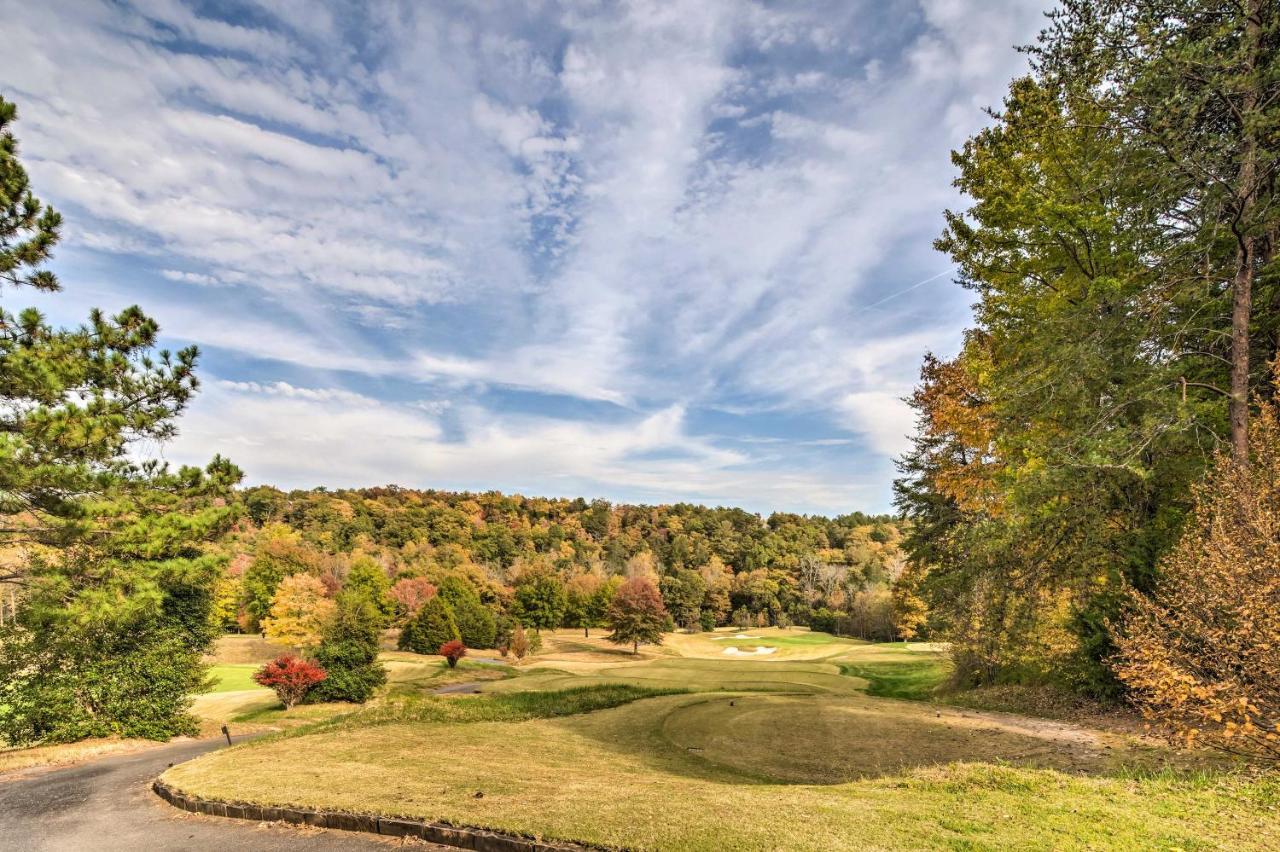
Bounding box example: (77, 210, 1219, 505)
(1228, 0, 1262, 464)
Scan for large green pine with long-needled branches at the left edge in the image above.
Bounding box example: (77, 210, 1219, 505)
(0, 99, 241, 745)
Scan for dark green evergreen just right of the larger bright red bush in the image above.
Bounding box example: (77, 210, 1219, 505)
(307, 588, 387, 704)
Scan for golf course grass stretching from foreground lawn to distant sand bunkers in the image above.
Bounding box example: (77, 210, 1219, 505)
(163, 628, 1280, 849)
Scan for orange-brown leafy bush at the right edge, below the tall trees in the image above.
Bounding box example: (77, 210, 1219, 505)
(1116, 383, 1280, 760)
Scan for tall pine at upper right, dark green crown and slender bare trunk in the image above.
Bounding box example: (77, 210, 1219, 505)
(1034, 0, 1280, 461)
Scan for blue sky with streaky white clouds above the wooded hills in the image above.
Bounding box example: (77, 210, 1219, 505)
(0, 0, 1043, 514)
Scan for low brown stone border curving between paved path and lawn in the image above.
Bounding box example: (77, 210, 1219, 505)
(151, 778, 607, 852)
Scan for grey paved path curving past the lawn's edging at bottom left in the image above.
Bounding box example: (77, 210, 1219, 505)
(0, 739, 448, 852)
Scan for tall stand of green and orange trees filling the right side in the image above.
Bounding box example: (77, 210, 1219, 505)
(896, 0, 1280, 752)
